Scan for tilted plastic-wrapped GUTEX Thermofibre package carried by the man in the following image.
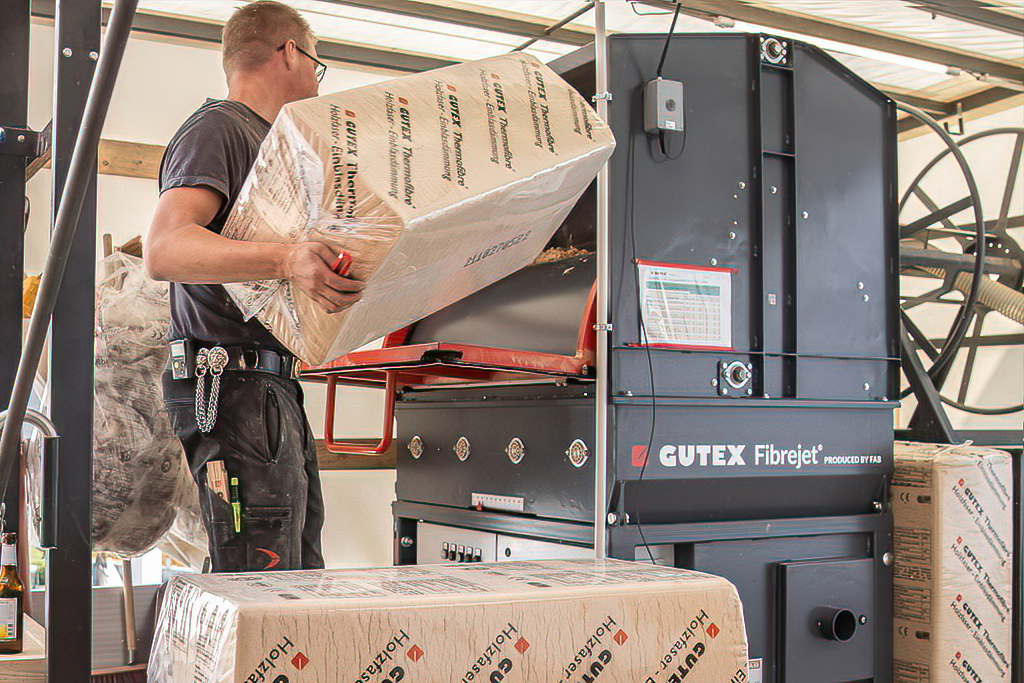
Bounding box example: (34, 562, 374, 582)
(223, 53, 614, 365)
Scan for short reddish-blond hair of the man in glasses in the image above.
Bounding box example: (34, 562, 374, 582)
(222, 0, 315, 78)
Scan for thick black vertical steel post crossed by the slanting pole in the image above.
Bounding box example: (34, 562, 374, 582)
(46, 0, 100, 683)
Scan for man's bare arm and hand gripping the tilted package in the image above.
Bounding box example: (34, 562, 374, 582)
(144, 187, 362, 312)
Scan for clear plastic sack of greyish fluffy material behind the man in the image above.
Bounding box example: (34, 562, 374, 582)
(92, 252, 198, 557)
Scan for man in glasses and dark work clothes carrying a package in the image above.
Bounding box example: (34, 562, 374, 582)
(145, 0, 362, 571)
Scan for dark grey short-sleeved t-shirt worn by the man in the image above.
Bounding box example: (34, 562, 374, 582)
(160, 99, 285, 352)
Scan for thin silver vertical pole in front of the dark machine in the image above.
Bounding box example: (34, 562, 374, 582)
(594, 0, 611, 558)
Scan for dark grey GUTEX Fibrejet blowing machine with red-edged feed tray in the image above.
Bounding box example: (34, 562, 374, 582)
(308, 34, 899, 683)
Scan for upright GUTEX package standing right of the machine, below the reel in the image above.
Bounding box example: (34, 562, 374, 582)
(892, 442, 1013, 683)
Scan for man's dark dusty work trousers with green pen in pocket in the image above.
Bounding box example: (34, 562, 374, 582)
(164, 372, 324, 571)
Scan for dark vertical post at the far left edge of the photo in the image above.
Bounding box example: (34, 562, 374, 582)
(0, 0, 31, 549)
